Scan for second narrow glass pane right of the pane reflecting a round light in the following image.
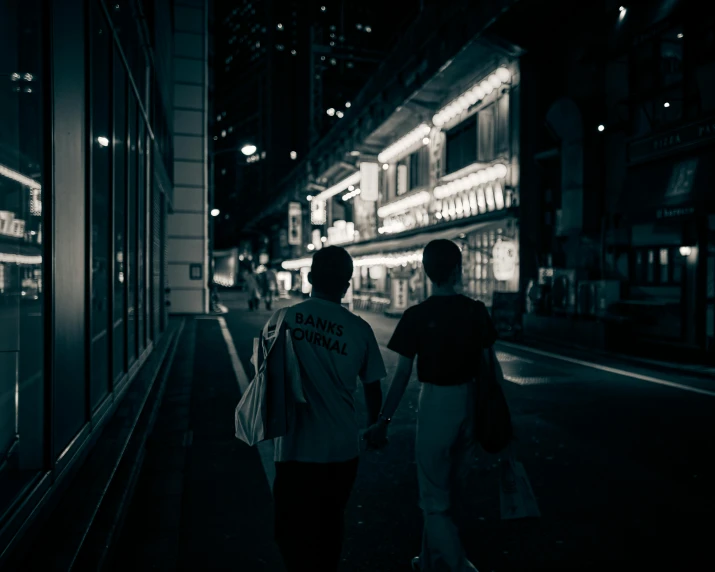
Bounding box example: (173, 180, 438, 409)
(126, 96, 139, 366)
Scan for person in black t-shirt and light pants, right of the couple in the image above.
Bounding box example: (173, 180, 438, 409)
(366, 240, 497, 572)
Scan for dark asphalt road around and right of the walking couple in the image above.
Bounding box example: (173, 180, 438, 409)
(222, 294, 715, 572)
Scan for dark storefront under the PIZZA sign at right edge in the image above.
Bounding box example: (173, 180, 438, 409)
(614, 115, 715, 358)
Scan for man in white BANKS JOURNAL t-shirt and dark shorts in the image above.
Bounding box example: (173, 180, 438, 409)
(273, 246, 386, 572)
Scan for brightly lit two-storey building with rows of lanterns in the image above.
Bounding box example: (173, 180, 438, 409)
(283, 4, 520, 313)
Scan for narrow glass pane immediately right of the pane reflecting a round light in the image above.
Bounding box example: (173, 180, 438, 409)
(113, 47, 127, 380)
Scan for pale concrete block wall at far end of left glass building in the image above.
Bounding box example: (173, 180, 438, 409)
(167, 0, 209, 314)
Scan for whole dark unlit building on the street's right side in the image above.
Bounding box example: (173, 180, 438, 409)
(496, 0, 715, 359)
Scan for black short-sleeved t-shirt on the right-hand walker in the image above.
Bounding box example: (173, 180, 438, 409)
(387, 295, 497, 385)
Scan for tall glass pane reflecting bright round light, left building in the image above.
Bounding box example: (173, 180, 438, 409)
(89, 2, 113, 408)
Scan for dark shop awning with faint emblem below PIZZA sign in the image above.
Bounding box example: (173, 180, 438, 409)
(618, 153, 715, 222)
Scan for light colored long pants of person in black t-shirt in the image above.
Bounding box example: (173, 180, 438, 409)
(415, 383, 476, 572)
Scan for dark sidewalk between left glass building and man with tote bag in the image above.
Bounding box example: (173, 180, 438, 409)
(111, 318, 283, 572)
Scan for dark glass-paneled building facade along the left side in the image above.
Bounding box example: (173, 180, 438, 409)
(0, 0, 205, 566)
